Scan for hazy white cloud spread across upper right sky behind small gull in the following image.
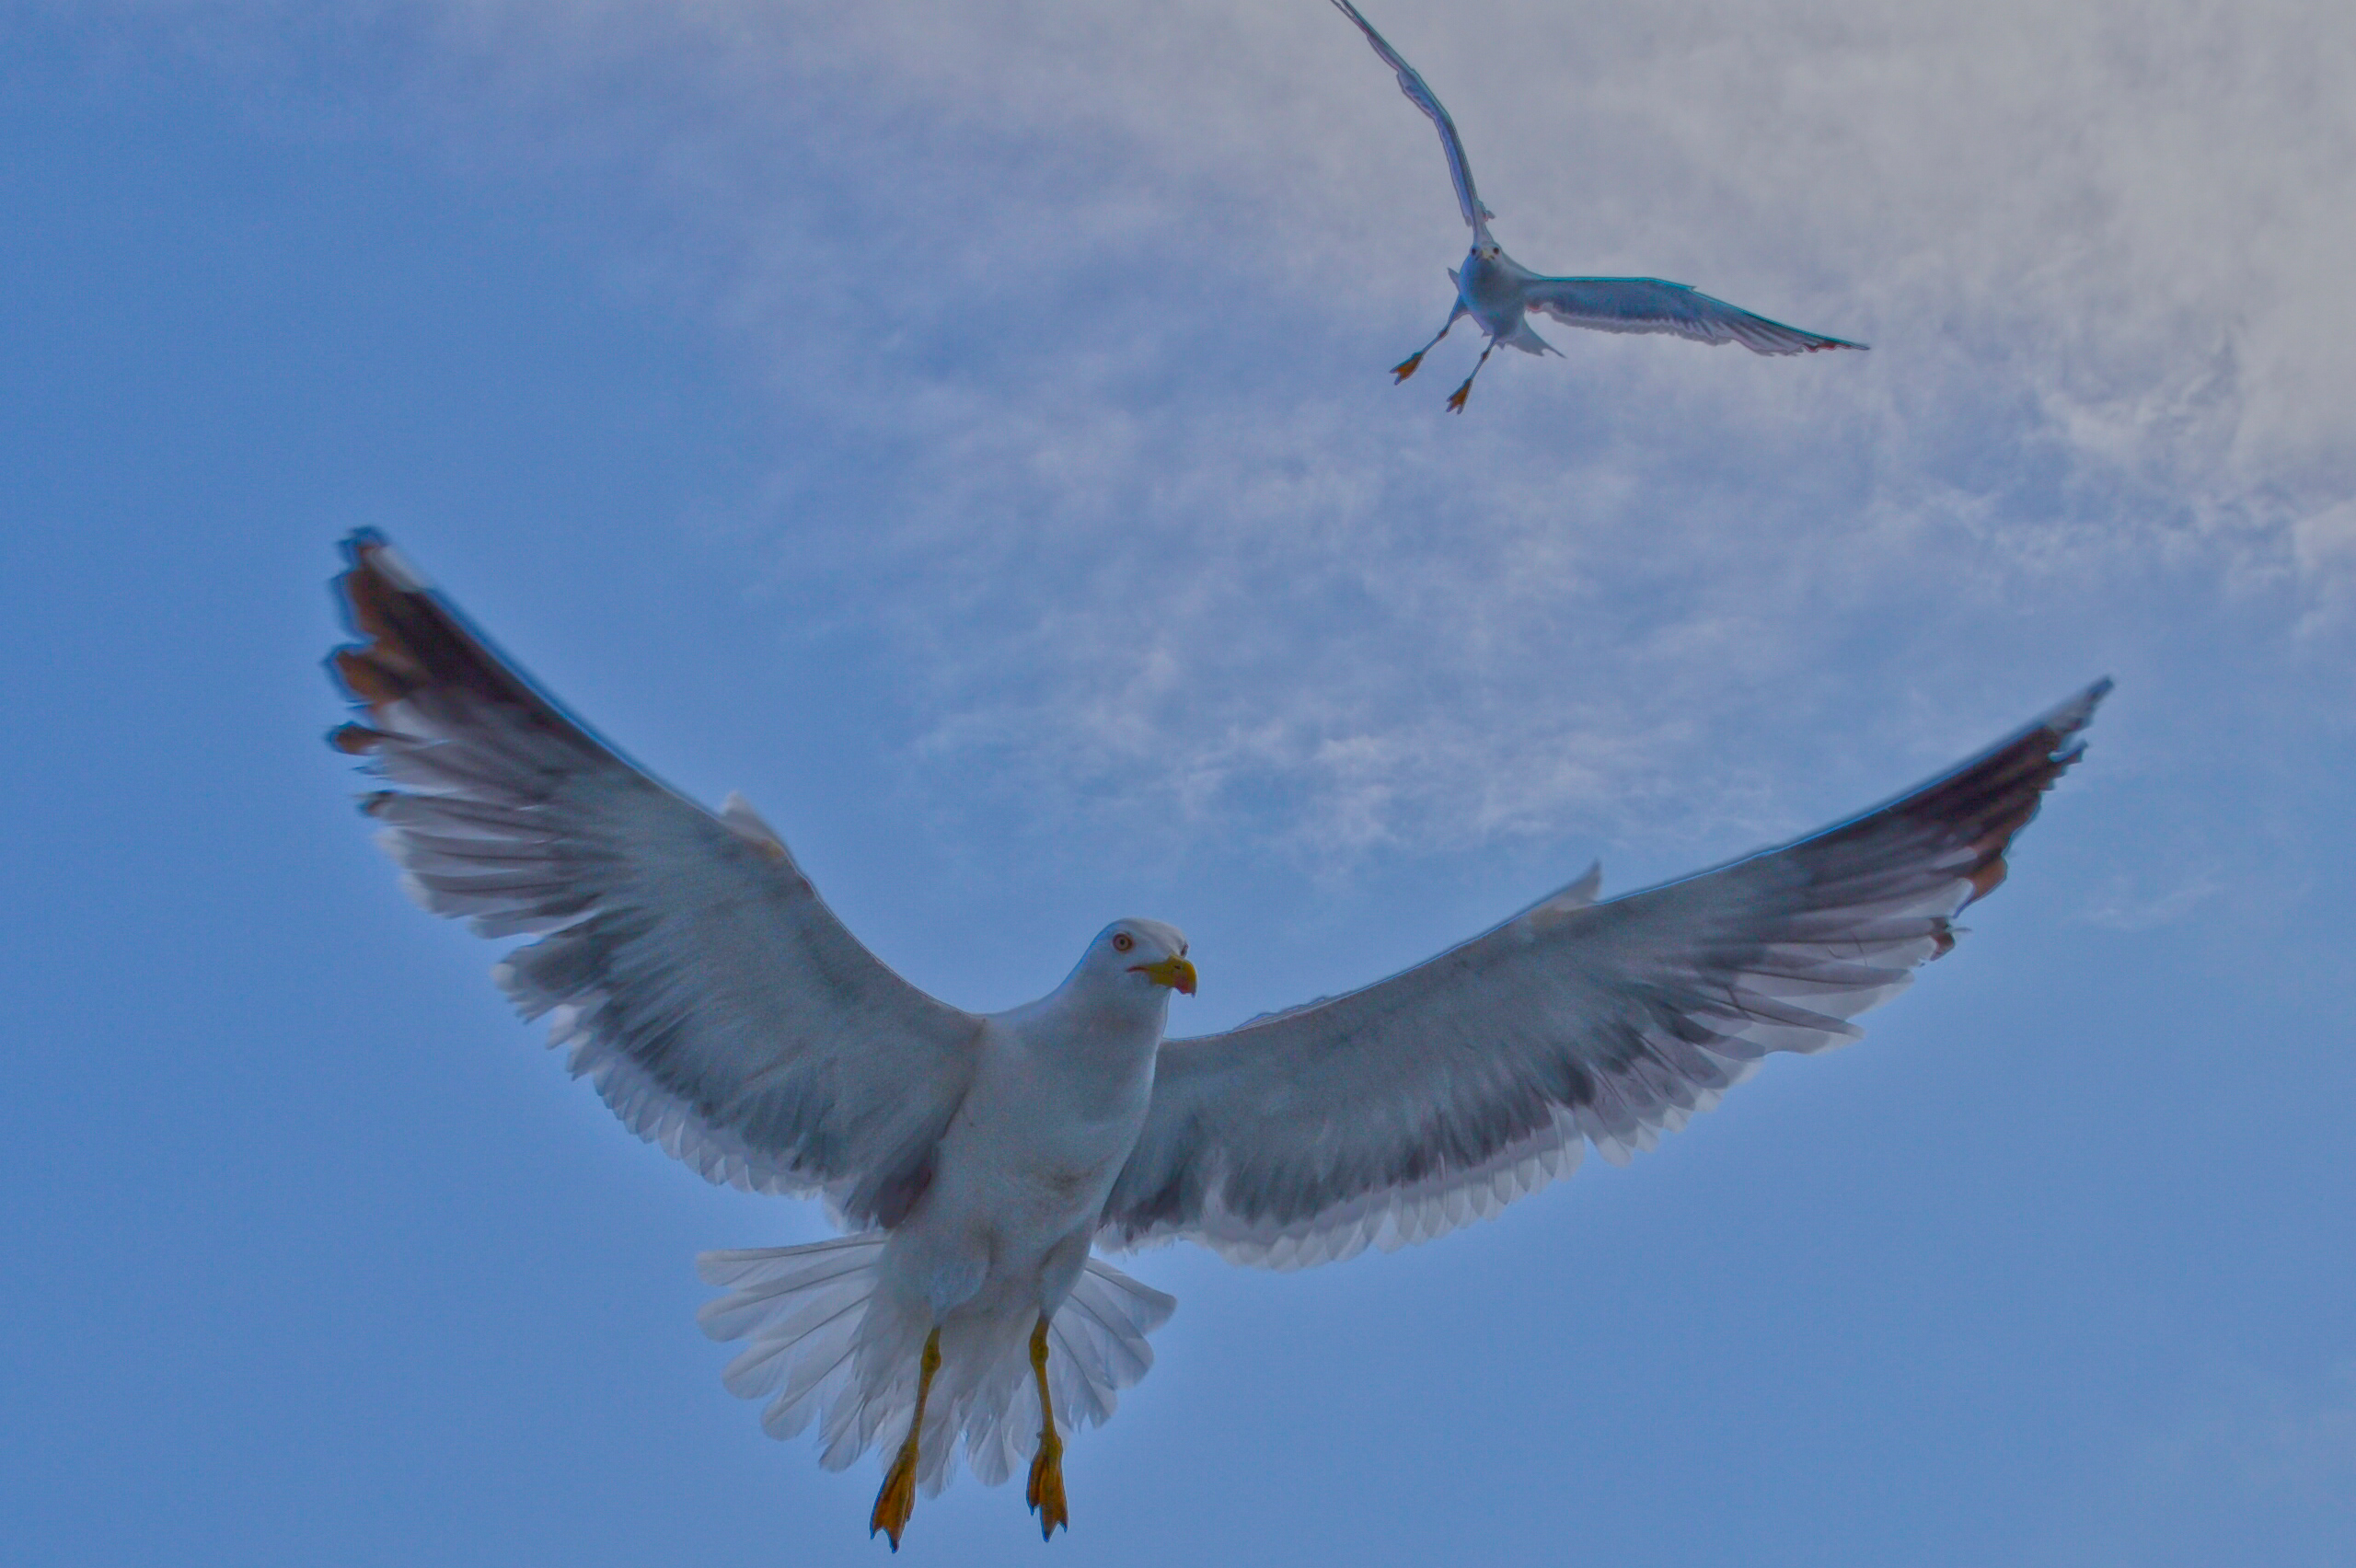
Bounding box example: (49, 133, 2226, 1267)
(91, 0, 2356, 855)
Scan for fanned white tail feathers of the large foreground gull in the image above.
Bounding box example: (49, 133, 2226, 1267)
(695, 1231, 1178, 1493)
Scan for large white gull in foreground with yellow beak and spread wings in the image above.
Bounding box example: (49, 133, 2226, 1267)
(329, 532, 2111, 1551)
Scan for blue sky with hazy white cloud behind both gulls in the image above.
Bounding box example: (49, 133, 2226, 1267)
(0, 0, 2356, 1568)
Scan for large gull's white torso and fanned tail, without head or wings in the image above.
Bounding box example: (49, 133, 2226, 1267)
(702, 961, 1173, 1493)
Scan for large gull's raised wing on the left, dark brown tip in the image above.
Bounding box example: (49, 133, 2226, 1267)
(328, 532, 980, 1224)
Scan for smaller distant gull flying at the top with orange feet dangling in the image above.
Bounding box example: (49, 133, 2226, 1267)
(1334, 0, 1864, 414)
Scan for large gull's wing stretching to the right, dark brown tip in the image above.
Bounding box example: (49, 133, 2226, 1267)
(1098, 680, 2108, 1269)
